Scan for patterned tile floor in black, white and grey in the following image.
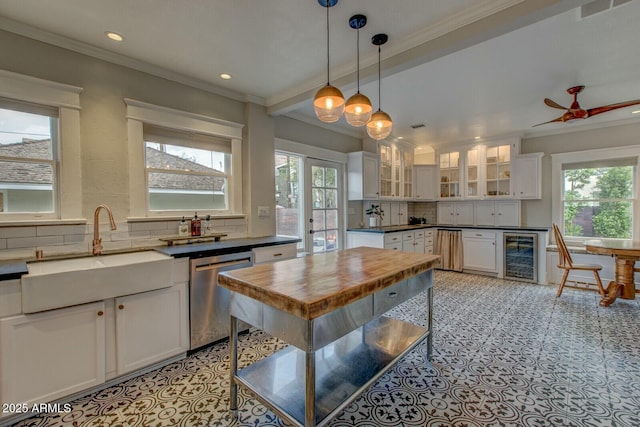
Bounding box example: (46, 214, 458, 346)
(8, 271, 640, 427)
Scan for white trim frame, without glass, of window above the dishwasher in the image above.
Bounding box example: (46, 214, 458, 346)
(124, 98, 244, 219)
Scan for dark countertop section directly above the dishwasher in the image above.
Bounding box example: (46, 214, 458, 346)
(156, 236, 300, 258)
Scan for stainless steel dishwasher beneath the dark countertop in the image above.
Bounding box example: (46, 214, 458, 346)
(189, 252, 253, 350)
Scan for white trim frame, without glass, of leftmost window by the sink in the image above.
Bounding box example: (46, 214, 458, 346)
(0, 70, 84, 223)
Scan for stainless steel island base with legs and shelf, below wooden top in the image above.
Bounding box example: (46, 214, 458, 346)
(229, 270, 433, 427)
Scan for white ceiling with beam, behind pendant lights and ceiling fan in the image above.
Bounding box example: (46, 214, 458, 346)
(0, 0, 640, 146)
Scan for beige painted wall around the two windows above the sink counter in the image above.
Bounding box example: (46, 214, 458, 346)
(0, 30, 361, 241)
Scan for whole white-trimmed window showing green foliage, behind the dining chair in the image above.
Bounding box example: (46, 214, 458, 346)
(552, 147, 640, 242)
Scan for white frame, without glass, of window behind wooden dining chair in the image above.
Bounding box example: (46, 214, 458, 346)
(551, 145, 640, 246)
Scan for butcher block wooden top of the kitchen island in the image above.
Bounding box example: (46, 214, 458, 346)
(218, 247, 440, 320)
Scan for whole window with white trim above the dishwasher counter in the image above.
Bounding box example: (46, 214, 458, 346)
(124, 98, 243, 218)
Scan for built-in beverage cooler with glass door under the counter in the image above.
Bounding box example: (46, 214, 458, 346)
(504, 233, 538, 283)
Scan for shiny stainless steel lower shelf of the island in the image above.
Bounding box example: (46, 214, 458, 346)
(234, 316, 429, 426)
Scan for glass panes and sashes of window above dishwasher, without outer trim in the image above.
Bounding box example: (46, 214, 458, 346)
(143, 124, 232, 212)
